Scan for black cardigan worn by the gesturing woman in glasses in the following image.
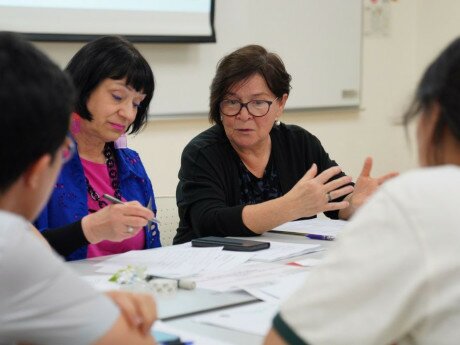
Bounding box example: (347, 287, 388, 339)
(174, 124, 344, 244)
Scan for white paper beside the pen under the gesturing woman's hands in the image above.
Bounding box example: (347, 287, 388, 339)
(273, 218, 347, 236)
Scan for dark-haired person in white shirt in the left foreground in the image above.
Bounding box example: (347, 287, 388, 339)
(0, 32, 156, 345)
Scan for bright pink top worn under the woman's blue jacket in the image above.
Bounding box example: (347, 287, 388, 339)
(81, 158, 145, 258)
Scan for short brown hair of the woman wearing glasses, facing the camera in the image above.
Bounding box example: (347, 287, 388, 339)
(209, 45, 291, 125)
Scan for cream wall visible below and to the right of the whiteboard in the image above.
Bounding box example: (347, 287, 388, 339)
(37, 0, 460, 196)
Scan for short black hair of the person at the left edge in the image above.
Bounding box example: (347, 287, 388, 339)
(0, 32, 74, 193)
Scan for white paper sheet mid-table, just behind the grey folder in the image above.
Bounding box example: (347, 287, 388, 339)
(192, 262, 303, 292)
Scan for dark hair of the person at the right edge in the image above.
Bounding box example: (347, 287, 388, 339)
(403, 38, 460, 159)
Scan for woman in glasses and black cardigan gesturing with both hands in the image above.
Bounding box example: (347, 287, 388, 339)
(174, 45, 395, 244)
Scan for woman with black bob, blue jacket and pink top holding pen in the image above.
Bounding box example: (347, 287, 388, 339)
(35, 36, 161, 260)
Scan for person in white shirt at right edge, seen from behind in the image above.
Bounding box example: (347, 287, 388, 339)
(265, 38, 460, 345)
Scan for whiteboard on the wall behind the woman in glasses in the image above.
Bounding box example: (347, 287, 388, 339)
(137, 0, 362, 117)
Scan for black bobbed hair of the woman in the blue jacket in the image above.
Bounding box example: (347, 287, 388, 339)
(66, 36, 155, 133)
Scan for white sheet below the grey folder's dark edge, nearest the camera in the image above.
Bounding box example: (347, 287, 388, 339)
(193, 302, 278, 336)
